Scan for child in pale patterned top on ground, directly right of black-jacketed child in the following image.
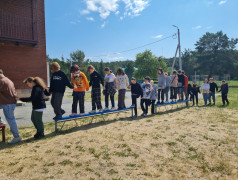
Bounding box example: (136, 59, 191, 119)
(140, 76, 152, 117)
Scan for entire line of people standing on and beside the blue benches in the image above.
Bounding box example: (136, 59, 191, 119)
(0, 62, 229, 143)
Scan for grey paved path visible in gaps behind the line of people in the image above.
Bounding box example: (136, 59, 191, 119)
(0, 91, 210, 127)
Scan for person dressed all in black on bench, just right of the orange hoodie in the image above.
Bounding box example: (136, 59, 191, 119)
(87, 65, 104, 114)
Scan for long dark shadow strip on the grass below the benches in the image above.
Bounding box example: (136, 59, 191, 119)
(0, 106, 190, 150)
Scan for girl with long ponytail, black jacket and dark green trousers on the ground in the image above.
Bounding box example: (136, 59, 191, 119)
(20, 77, 50, 139)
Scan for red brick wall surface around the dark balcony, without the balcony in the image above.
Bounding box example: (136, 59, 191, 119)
(0, 0, 47, 96)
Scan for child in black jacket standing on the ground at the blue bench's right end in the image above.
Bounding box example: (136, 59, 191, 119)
(129, 77, 143, 117)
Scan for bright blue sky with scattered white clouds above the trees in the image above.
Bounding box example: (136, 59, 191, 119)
(45, 0, 238, 62)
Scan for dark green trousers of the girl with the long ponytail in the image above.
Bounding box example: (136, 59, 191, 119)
(31, 109, 44, 134)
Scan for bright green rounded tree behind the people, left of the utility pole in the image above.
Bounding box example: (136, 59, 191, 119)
(134, 50, 167, 79)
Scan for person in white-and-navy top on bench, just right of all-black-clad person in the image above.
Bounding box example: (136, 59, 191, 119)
(103, 67, 117, 111)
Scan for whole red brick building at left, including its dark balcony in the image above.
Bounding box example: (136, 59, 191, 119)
(0, 0, 47, 94)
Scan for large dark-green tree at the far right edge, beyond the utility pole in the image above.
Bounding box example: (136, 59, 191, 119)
(195, 31, 238, 76)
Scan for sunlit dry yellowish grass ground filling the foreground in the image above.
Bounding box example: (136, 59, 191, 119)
(0, 106, 238, 180)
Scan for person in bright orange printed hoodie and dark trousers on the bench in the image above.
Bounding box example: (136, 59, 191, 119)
(70, 65, 89, 116)
